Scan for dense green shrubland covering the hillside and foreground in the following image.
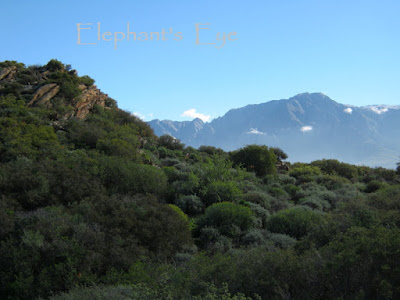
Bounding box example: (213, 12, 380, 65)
(0, 61, 400, 299)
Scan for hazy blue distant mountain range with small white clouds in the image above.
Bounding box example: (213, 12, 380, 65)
(149, 93, 400, 168)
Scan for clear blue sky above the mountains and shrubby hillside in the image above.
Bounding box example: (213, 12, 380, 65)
(0, 0, 400, 120)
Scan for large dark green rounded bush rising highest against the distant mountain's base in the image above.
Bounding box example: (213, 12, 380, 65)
(231, 145, 276, 176)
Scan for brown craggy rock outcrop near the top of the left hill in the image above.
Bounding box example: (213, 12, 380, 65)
(0, 66, 108, 120)
